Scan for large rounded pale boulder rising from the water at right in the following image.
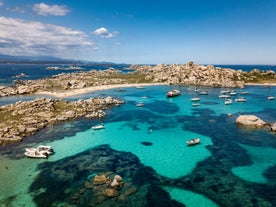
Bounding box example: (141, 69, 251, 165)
(236, 115, 270, 128)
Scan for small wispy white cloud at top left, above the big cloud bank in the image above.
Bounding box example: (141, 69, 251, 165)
(32, 0, 70, 16)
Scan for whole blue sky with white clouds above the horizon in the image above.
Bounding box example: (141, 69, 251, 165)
(0, 0, 276, 64)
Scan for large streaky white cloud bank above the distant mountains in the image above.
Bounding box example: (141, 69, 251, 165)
(0, 17, 94, 58)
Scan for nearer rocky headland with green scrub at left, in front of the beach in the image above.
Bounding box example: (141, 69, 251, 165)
(0, 97, 124, 146)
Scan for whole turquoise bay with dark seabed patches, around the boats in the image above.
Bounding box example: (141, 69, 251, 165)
(0, 65, 276, 207)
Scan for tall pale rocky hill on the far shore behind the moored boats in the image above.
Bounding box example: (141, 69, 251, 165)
(132, 62, 244, 88)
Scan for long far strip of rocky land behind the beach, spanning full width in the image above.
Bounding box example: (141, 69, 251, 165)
(0, 62, 276, 97)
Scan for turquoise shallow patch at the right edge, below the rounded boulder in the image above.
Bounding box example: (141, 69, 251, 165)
(232, 145, 276, 183)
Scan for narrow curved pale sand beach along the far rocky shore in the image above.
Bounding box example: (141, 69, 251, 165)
(36, 83, 166, 98)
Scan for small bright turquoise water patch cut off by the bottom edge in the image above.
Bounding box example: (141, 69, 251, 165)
(163, 187, 218, 207)
